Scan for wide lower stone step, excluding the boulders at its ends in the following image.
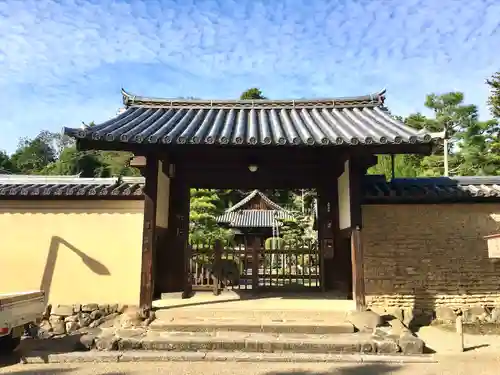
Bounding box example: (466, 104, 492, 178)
(114, 332, 390, 354)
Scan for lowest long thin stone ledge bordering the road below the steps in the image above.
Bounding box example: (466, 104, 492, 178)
(17, 351, 438, 364)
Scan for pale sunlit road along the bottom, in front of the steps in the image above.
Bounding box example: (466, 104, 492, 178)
(0, 357, 500, 375)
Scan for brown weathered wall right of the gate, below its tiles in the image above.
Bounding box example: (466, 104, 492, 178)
(362, 203, 500, 311)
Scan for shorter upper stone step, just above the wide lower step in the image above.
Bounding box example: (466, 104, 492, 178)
(148, 318, 354, 335)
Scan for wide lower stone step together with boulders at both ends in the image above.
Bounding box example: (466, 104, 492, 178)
(18, 328, 424, 355)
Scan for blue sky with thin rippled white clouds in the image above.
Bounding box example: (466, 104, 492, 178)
(0, 0, 500, 153)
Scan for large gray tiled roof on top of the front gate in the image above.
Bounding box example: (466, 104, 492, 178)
(63, 90, 442, 146)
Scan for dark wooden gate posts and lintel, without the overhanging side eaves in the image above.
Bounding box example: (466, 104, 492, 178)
(132, 149, 376, 309)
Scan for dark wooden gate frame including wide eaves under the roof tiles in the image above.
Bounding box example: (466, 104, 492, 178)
(77, 139, 432, 310)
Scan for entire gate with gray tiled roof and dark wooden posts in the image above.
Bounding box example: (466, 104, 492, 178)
(68, 90, 442, 309)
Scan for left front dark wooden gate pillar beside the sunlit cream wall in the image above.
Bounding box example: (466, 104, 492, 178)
(136, 154, 158, 310)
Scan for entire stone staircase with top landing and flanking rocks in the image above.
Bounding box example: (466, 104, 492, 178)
(18, 297, 424, 355)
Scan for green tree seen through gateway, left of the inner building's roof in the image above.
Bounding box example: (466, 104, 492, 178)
(189, 189, 232, 243)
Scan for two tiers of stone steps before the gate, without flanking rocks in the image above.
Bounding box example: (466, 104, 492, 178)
(104, 308, 418, 354)
